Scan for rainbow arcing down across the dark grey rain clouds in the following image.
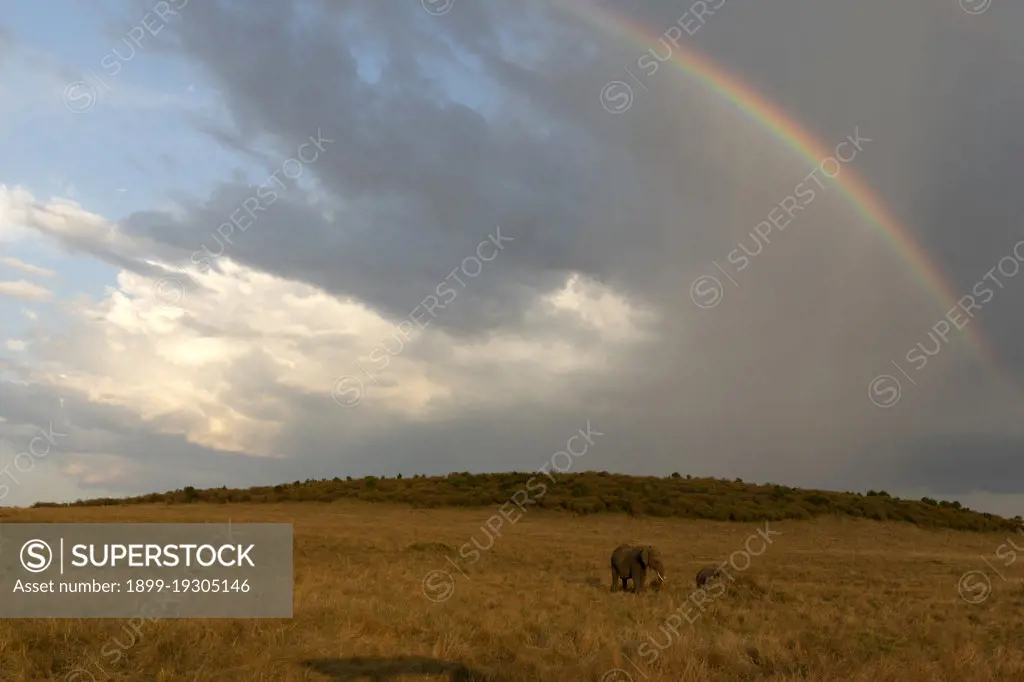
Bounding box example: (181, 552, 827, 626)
(557, 0, 992, 364)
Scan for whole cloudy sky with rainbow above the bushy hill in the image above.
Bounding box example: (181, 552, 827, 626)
(0, 0, 1024, 509)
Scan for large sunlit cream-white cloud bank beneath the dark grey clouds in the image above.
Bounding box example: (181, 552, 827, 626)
(39, 249, 650, 456)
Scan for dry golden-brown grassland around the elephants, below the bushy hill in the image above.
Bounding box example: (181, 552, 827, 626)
(0, 502, 1024, 682)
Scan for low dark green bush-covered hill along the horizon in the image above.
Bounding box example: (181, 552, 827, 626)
(29, 471, 1021, 531)
